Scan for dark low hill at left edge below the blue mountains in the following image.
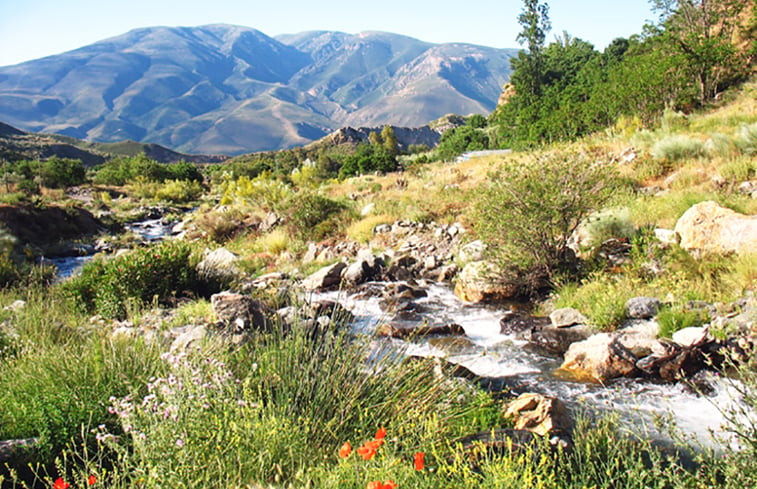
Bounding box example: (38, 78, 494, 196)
(0, 122, 226, 166)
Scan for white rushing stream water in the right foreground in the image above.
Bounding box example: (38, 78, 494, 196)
(314, 284, 732, 445)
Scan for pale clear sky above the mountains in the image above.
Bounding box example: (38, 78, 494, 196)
(0, 0, 654, 66)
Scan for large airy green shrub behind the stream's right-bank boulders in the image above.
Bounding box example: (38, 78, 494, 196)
(474, 153, 617, 276)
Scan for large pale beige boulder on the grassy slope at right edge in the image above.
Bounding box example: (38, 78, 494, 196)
(675, 201, 757, 254)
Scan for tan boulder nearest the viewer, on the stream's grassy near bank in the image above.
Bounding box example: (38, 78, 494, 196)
(505, 392, 573, 436)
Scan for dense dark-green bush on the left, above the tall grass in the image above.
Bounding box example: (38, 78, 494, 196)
(61, 241, 198, 318)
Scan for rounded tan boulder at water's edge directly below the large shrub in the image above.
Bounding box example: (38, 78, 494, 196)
(455, 261, 520, 303)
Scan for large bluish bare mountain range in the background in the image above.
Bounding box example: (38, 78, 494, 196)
(0, 25, 517, 154)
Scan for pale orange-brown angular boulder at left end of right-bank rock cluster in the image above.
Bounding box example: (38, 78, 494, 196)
(560, 333, 637, 383)
